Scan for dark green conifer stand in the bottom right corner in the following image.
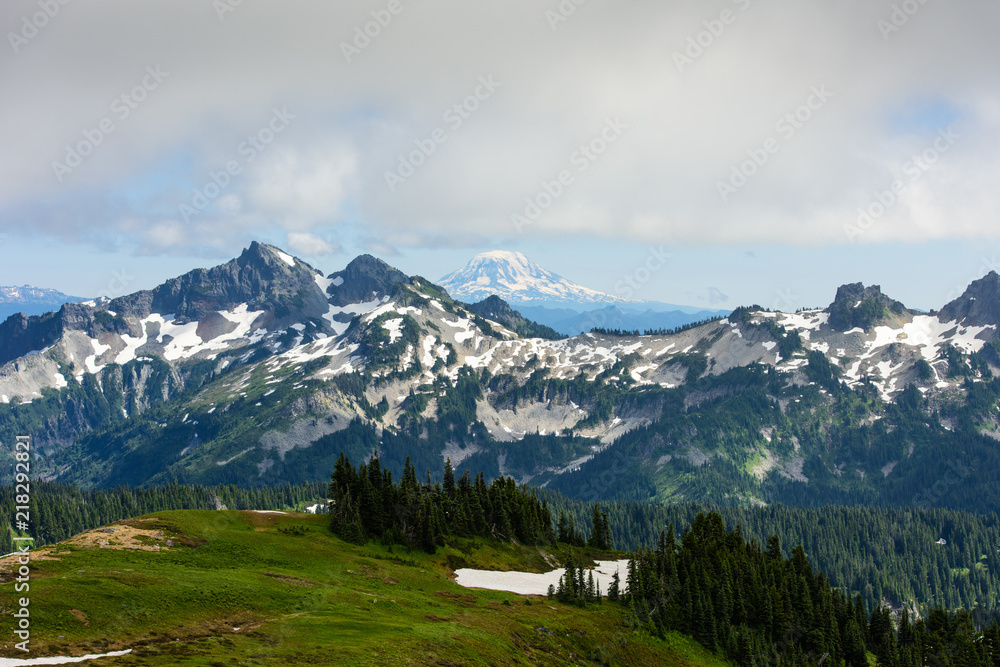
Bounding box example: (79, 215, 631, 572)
(608, 512, 1000, 667)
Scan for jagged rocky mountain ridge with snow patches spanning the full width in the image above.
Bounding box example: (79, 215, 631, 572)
(0, 245, 1000, 506)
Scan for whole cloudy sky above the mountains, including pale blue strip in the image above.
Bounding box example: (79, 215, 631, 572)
(0, 0, 1000, 310)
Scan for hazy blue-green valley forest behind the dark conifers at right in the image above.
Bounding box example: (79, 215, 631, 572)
(539, 490, 1000, 611)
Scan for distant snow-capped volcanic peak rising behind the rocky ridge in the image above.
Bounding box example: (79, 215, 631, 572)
(437, 250, 623, 305)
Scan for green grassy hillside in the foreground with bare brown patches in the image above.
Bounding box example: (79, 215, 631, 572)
(0, 511, 724, 666)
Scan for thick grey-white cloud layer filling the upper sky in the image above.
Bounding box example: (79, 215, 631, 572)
(0, 0, 1000, 253)
